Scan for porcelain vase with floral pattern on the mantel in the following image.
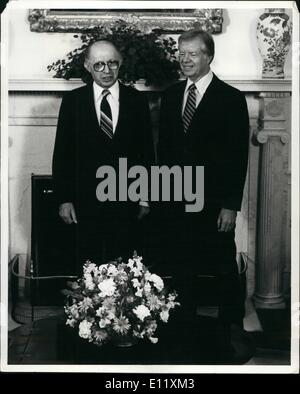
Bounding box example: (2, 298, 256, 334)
(256, 8, 292, 78)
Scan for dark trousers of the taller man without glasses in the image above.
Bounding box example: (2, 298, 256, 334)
(156, 206, 245, 326)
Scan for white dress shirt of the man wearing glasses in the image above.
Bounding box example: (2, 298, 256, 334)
(93, 81, 120, 133)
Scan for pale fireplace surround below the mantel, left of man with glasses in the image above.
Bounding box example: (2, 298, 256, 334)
(8, 92, 60, 259)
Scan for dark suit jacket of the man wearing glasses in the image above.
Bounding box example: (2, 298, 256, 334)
(53, 84, 154, 222)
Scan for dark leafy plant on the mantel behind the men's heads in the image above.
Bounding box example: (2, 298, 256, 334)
(47, 19, 180, 86)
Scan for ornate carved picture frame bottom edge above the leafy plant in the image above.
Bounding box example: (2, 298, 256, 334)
(28, 8, 223, 34)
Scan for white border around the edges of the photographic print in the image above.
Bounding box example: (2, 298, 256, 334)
(1, 0, 299, 374)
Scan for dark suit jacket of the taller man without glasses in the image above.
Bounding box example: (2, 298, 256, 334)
(158, 75, 249, 211)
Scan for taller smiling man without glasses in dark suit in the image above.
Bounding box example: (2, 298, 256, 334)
(159, 30, 249, 350)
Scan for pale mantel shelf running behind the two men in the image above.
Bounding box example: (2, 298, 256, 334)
(9, 77, 292, 92)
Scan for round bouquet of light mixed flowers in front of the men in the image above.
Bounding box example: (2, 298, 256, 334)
(64, 254, 180, 346)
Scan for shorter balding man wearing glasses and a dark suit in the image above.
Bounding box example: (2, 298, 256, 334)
(53, 40, 154, 274)
